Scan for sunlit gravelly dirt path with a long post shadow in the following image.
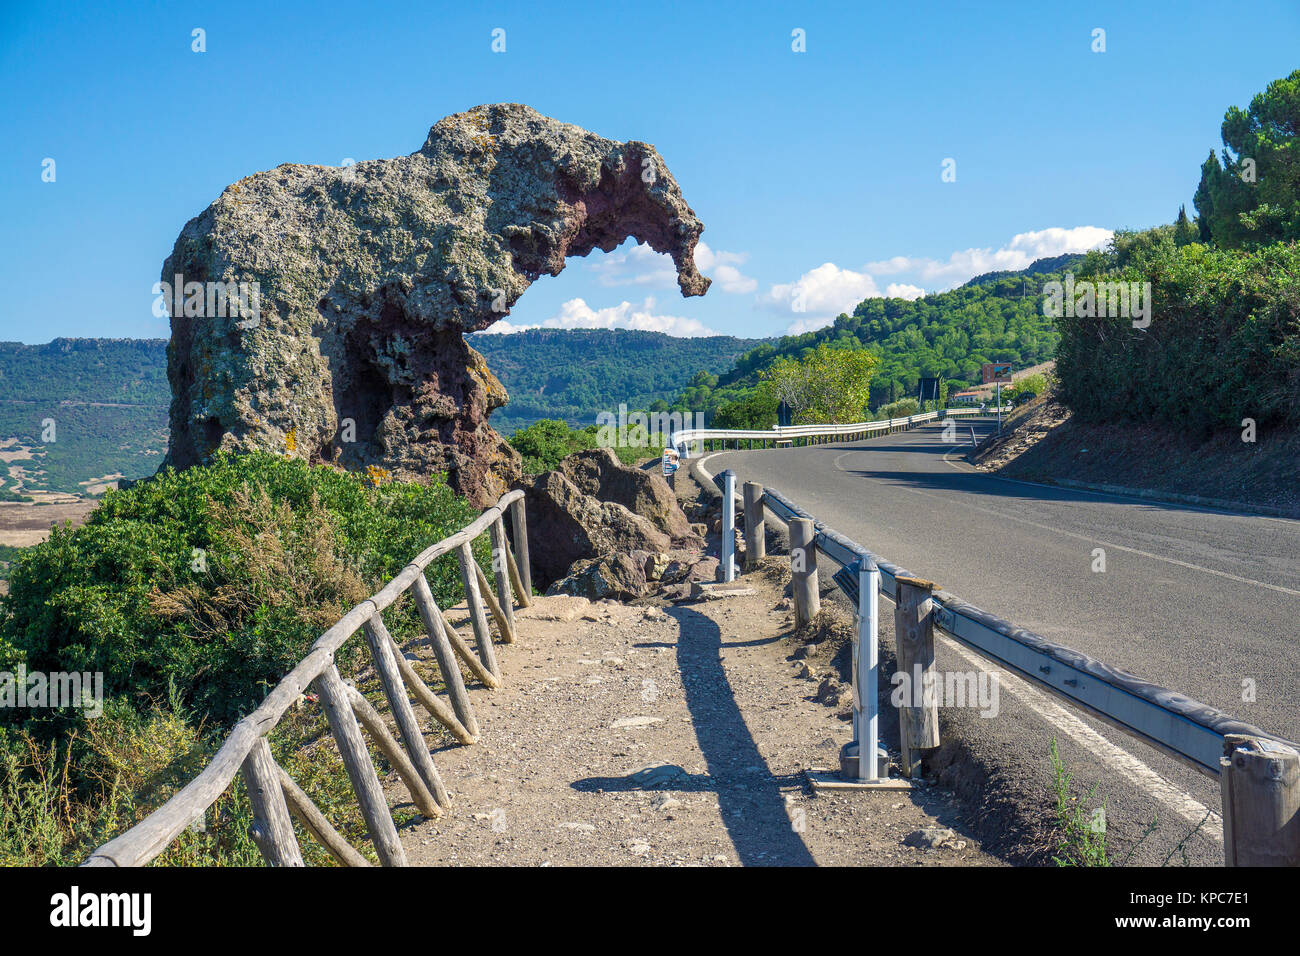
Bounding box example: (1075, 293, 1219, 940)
(386, 575, 997, 866)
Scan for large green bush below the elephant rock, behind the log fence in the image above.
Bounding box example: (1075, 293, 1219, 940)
(0, 454, 488, 728)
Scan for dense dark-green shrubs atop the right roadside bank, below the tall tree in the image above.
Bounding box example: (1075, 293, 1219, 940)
(1057, 239, 1300, 434)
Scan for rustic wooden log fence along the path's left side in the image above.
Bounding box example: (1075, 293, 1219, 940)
(85, 490, 532, 866)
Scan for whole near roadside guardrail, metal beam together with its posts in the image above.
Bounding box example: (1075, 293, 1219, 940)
(712, 410, 1300, 866)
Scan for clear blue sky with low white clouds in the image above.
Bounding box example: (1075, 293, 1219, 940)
(0, 0, 1300, 342)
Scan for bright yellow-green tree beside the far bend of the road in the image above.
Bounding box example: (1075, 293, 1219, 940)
(759, 342, 879, 424)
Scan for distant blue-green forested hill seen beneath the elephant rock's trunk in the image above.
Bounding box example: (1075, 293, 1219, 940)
(465, 329, 763, 434)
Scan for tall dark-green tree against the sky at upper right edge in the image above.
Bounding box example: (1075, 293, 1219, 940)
(1195, 70, 1300, 248)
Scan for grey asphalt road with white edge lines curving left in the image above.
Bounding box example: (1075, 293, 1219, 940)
(706, 420, 1300, 865)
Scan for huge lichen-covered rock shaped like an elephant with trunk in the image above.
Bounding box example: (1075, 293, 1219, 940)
(163, 104, 709, 505)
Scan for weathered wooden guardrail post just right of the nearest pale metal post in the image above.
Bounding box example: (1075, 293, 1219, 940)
(894, 576, 939, 777)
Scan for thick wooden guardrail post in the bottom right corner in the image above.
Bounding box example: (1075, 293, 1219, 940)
(1219, 734, 1300, 866)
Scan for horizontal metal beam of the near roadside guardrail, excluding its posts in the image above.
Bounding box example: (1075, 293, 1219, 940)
(762, 488, 1300, 777)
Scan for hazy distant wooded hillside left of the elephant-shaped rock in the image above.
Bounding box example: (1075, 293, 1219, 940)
(0, 338, 172, 494)
